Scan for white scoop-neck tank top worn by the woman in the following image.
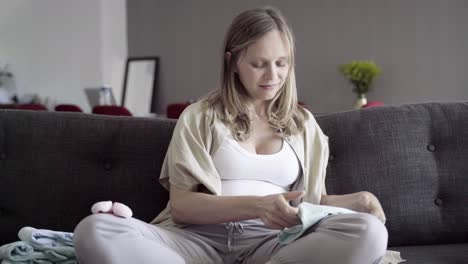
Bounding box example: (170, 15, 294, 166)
(213, 135, 300, 196)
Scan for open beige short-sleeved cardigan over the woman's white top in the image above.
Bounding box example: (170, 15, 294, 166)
(151, 101, 329, 226)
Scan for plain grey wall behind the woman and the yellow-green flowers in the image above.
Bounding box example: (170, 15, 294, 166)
(127, 0, 468, 112)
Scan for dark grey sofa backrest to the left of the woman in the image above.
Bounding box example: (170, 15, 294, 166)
(0, 110, 175, 245)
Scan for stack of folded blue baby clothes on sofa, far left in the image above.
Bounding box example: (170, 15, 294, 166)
(0, 227, 78, 264)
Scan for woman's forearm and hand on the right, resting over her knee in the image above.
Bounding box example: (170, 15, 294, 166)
(320, 192, 386, 223)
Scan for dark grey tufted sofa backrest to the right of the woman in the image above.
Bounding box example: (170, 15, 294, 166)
(317, 103, 468, 246)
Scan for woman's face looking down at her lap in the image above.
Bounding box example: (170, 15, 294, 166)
(237, 30, 289, 105)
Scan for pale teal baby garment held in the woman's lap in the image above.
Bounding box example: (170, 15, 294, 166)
(278, 202, 355, 245)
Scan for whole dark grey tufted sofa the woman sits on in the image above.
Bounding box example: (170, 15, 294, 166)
(0, 103, 468, 264)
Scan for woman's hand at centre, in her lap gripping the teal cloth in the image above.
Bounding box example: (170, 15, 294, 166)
(257, 191, 304, 230)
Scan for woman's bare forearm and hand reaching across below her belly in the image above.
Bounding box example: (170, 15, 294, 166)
(170, 185, 303, 229)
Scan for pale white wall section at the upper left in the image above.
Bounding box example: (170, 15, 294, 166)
(0, 0, 127, 111)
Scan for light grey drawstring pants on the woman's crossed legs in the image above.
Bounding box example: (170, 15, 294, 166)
(74, 213, 388, 264)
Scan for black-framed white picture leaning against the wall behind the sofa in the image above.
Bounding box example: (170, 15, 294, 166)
(121, 56, 159, 116)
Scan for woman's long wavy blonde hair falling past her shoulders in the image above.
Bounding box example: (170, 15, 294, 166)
(207, 7, 307, 141)
